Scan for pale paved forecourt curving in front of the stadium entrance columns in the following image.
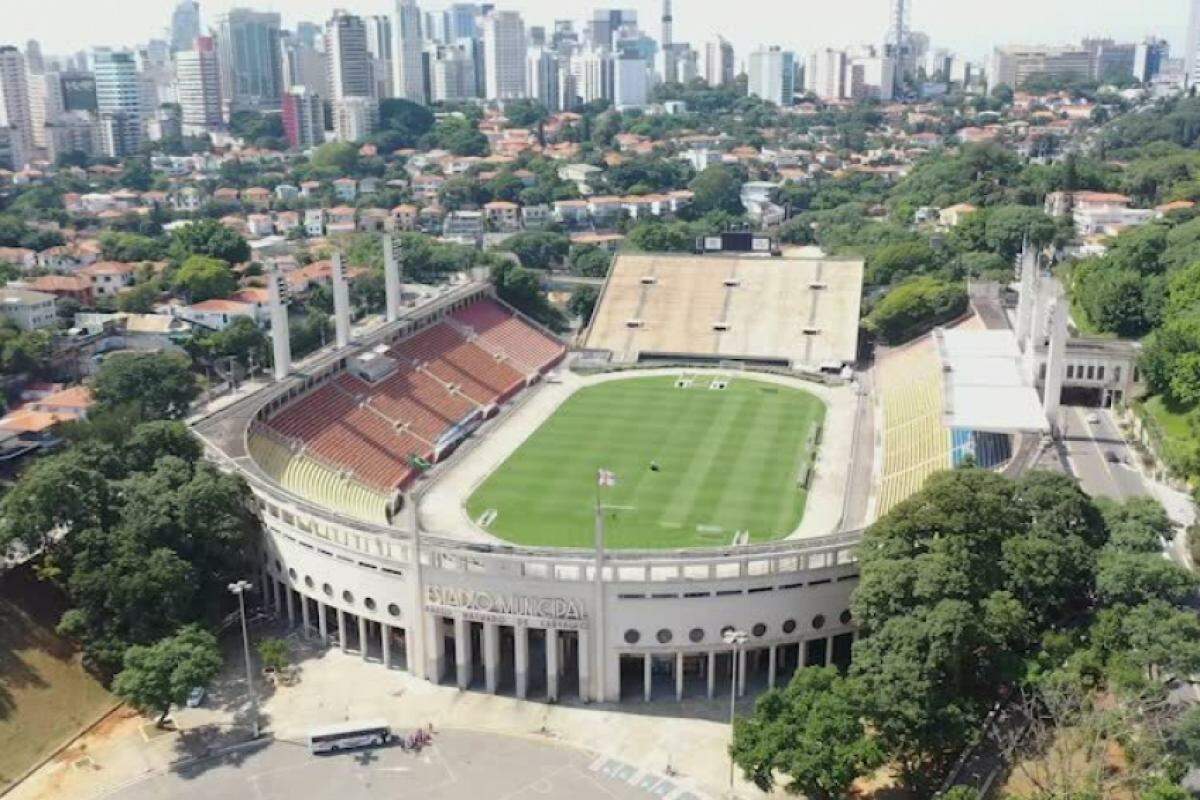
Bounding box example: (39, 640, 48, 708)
(6, 645, 764, 800)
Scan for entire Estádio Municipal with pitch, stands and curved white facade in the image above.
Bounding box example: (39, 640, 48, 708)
(193, 242, 1104, 702)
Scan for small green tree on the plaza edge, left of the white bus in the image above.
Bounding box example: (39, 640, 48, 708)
(113, 625, 222, 727)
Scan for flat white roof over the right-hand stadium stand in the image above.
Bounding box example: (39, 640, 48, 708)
(935, 329, 1050, 433)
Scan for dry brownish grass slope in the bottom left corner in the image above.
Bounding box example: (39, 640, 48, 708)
(0, 570, 114, 792)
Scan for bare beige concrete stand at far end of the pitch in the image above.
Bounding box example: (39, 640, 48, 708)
(584, 253, 863, 369)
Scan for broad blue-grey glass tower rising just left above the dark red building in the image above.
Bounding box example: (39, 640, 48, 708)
(216, 8, 283, 115)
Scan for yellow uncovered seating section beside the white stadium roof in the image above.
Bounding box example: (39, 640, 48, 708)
(876, 337, 952, 516)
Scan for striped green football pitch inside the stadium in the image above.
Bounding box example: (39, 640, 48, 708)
(467, 374, 824, 549)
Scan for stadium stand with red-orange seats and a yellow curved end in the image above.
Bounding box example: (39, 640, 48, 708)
(252, 299, 566, 501)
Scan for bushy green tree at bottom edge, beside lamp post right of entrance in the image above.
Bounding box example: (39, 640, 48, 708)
(730, 667, 882, 800)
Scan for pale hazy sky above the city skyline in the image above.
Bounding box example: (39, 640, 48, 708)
(0, 0, 1188, 61)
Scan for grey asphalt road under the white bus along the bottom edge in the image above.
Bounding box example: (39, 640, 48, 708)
(106, 730, 704, 800)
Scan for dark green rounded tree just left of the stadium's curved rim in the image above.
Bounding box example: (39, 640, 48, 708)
(91, 353, 200, 420)
